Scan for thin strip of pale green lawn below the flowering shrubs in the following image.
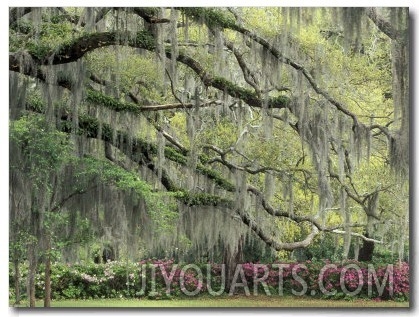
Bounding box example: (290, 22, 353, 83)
(10, 295, 409, 308)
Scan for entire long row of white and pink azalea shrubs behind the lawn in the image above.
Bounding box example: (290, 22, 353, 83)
(9, 259, 410, 301)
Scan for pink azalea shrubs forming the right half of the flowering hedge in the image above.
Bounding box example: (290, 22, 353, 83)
(242, 260, 410, 301)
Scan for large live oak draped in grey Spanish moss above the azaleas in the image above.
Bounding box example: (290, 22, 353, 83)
(9, 7, 409, 304)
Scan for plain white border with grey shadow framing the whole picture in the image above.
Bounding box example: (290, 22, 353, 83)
(0, 0, 419, 316)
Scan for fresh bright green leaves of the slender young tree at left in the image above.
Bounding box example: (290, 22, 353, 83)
(10, 115, 177, 230)
